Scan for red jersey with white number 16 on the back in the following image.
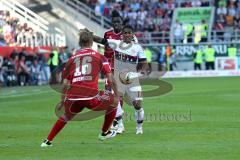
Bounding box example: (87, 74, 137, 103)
(62, 48, 111, 100)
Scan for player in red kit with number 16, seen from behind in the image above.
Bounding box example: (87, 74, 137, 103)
(41, 31, 121, 147)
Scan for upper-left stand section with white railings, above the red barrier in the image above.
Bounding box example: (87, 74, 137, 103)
(0, 0, 66, 47)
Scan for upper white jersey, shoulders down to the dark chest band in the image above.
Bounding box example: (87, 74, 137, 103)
(107, 39, 146, 63)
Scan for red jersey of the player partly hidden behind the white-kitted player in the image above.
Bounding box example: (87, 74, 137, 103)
(104, 29, 122, 69)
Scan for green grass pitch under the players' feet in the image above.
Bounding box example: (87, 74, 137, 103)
(0, 77, 240, 160)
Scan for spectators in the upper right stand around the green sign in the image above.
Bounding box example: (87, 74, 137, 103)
(79, 0, 240, 43)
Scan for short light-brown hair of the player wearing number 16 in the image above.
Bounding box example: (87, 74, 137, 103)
(79, 31, 93, 47)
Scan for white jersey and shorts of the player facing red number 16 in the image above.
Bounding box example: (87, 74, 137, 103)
(108, 39, 146, 101)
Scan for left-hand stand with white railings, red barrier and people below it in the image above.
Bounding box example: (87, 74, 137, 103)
(0, 1, 66, 86)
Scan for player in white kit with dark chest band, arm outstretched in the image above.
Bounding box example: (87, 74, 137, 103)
(91, 25, 148, 134)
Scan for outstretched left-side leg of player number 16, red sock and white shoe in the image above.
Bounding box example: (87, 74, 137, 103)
(41, 100, 83, 147)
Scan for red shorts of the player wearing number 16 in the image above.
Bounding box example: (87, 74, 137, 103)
(64, 92, 114, 120)
